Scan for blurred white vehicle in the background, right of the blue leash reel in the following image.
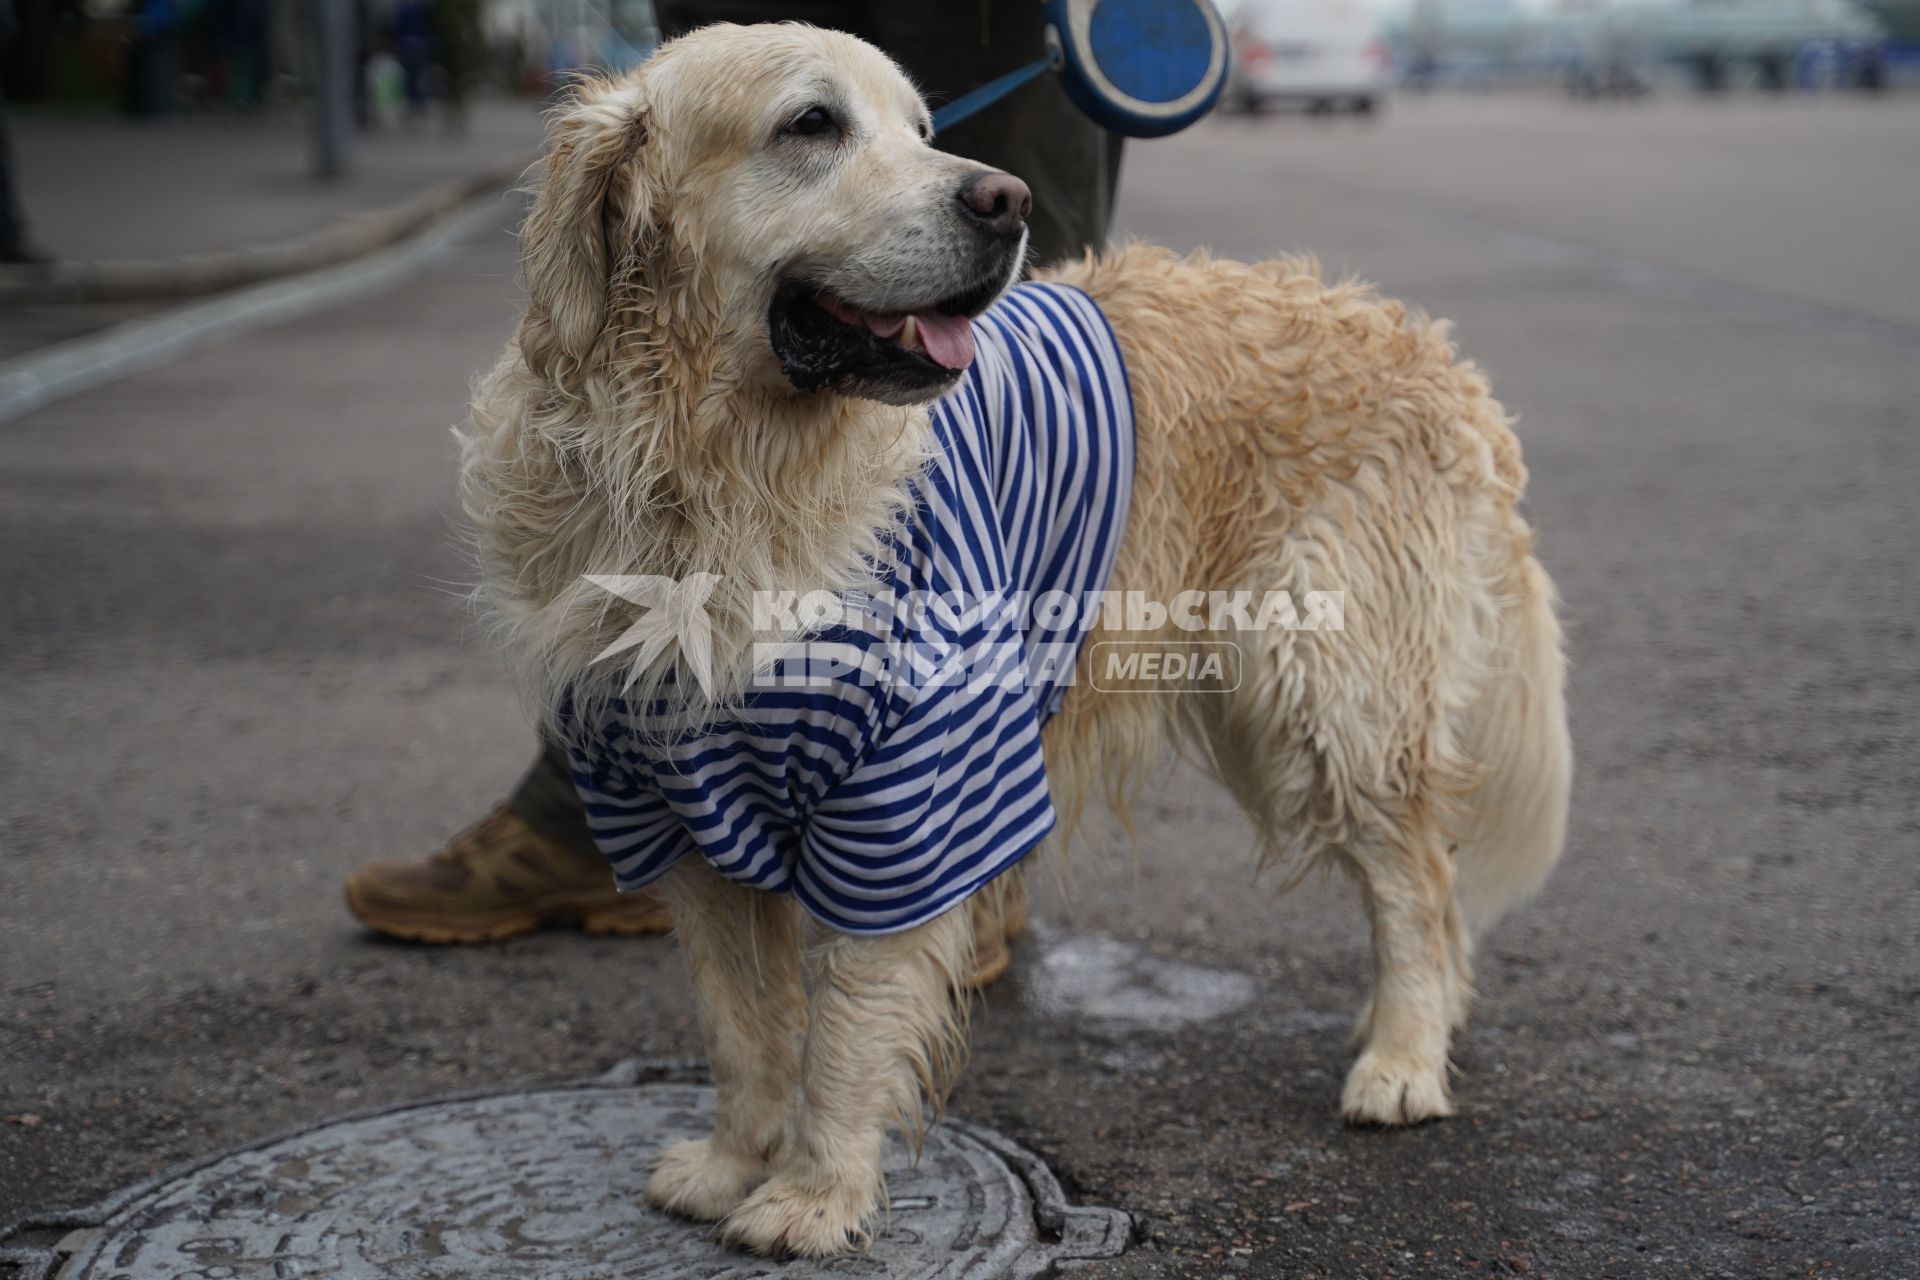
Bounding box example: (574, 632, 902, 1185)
(1225, 0, 1392, 111)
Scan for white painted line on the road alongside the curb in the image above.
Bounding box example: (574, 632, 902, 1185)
(0, 194, 501, 422)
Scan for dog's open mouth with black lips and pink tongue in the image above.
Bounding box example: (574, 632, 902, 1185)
(766, 280, 1004, 403)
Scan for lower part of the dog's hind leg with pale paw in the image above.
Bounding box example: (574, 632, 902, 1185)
(1340, 818, 1469, 1125)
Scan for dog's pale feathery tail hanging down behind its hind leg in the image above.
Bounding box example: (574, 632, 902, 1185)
(1453, 557, 1572, 933)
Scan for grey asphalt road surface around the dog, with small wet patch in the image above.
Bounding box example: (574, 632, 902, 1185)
(0, 100, 1920, 1278)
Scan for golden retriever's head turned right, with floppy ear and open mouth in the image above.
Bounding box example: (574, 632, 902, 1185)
(522, 23, 1029, 405)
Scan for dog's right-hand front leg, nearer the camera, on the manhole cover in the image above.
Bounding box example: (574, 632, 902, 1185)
(720, 910, 973, 1257)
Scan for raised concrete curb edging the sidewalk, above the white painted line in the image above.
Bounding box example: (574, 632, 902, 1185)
(0, 165, 524, 305)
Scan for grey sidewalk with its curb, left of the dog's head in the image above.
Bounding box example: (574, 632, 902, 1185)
(0, 100, 541, 359)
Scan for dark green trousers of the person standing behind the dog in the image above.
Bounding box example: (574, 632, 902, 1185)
(507, 0, 1121, 854)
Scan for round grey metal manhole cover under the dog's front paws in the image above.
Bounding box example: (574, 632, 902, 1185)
(0, 1059, 1129, 1280)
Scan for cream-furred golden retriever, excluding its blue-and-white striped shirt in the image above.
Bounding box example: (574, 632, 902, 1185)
(463, 25, 1571, 1257)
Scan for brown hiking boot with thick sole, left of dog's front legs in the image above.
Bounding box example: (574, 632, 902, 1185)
(348, 804, 672, 942)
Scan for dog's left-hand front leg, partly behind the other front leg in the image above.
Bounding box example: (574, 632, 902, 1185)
(647, 858, 806, 1222)
